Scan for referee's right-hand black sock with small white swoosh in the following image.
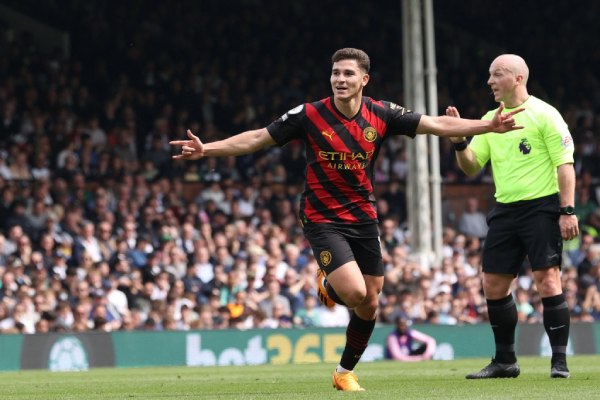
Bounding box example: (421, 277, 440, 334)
(542, 293, 571, 363)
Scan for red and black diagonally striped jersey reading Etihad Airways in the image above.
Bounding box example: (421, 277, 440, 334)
(267, 97, 421, 224)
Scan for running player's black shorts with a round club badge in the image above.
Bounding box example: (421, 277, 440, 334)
(304, 223, 383, 276)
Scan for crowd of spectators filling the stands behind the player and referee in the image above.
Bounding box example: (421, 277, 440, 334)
(0, 0, 600, 333)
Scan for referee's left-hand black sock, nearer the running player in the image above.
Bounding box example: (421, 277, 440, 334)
(487, 294, 518, 363)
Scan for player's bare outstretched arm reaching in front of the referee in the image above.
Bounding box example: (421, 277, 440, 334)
(417, 103, 525, 137)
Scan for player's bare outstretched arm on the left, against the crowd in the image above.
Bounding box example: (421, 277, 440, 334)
(169, 128, 275, 160)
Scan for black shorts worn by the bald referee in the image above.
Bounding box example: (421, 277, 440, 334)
(482, 194, 563, 276)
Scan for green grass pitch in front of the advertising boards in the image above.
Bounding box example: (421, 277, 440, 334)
(0, 356, 600, 400)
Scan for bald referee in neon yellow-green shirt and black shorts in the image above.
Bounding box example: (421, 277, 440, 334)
(446, 54, 579, 379)
